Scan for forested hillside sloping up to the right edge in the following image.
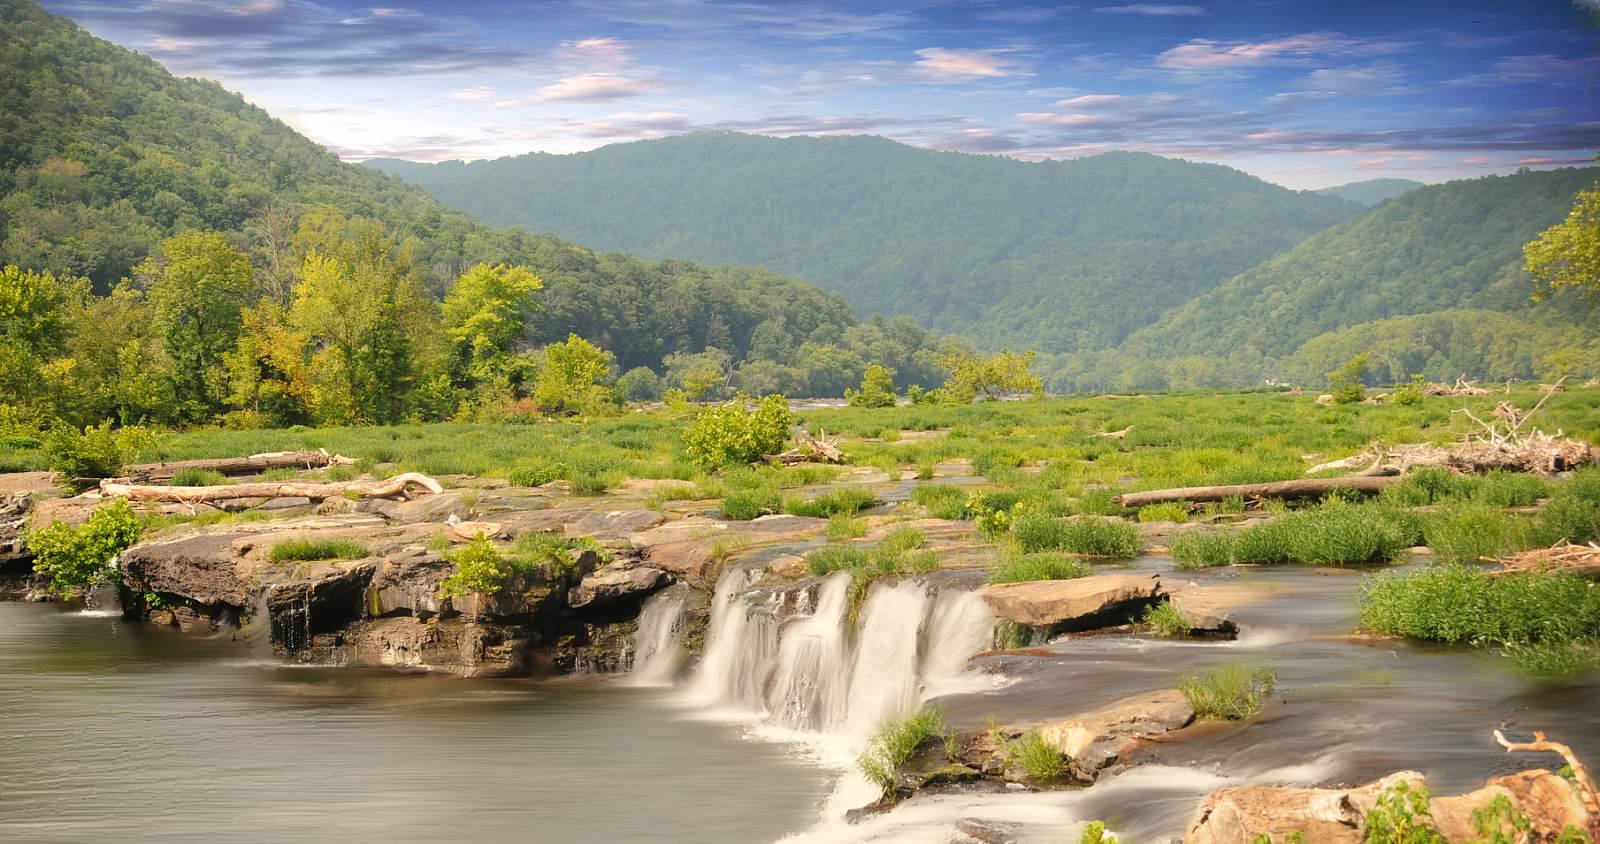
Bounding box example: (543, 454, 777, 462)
(1088, 168, 1600, 387)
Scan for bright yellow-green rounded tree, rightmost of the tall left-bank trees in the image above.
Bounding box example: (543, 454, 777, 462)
(443, 264, 544, 380)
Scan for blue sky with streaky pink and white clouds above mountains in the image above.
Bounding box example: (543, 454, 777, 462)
(34, 0, 1600, 189)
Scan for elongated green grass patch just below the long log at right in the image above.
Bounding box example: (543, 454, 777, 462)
(1170, 500, 1422, 569)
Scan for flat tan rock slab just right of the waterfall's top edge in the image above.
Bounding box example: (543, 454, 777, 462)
(979, 574, 1162, 630)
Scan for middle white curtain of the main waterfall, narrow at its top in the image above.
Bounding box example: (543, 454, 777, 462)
(768, 572, 850, 732)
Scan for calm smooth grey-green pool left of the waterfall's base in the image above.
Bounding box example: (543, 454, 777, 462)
(0, 603, 829, 844)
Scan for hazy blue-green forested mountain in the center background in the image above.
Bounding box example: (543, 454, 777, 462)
(370, 133, 1360, 352)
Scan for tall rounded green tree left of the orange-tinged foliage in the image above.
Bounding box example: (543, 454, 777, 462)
(136, 232, 253, 420)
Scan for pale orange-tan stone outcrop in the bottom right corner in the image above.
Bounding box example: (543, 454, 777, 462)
(1184, 770, 1595, 844)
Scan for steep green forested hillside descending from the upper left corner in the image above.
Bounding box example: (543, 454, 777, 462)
(0, 0, 938, 420)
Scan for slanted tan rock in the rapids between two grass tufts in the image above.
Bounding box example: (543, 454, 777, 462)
(1038, 689, 1195, 778)
